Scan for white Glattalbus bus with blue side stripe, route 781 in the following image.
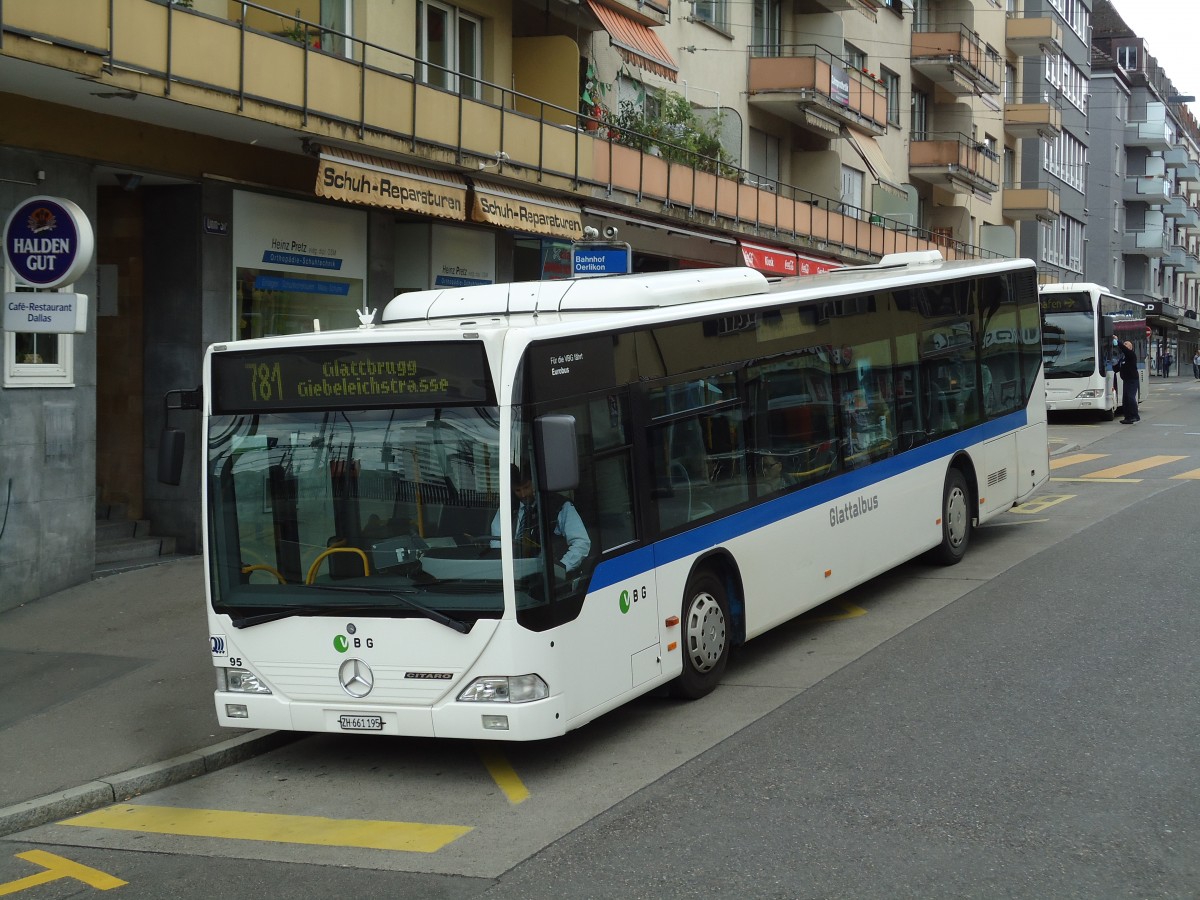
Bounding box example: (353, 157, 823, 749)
(177, 252, 1049, 740)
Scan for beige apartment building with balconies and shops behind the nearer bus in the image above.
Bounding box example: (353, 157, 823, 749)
(0, 0, 1132, 605)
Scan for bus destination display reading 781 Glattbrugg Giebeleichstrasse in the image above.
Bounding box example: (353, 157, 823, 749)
(212, 343, 492, 414)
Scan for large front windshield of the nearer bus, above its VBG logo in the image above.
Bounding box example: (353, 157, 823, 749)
(208, 406, 508, 626)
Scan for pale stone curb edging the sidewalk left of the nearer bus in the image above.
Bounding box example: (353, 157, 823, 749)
(0, 731, 301, 836)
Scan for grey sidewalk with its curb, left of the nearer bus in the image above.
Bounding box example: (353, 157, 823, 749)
(0, 557, 292, 834)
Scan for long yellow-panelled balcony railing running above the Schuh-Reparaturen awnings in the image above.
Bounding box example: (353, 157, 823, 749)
(0, 0, 995, 259)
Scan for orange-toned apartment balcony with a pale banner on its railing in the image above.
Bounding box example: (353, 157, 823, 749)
(749, 44, 888, 139)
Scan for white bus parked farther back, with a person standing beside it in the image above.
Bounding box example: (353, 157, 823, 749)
(1038, 283, 1148, 421)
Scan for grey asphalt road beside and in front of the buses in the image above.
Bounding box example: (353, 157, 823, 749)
(0, 385, 1200, 900)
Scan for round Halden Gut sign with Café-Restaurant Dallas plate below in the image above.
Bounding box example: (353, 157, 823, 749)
(4, 197, 95, 334)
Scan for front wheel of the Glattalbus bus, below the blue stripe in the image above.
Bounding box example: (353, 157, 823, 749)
(671, 570, 730, 700)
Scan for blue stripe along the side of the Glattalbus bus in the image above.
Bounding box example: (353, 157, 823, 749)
(589, 409, 1028, 590)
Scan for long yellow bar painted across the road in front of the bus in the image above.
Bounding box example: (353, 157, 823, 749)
(59, 803, 470, 853)
